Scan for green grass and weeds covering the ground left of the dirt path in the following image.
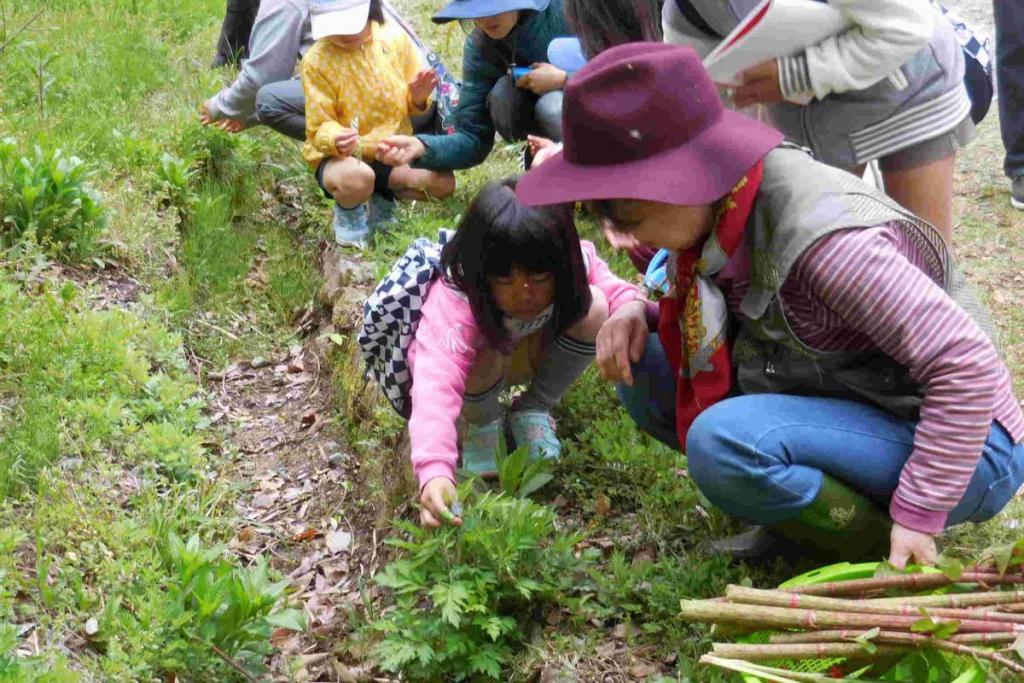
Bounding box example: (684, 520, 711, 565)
(0, 0, 315, 682)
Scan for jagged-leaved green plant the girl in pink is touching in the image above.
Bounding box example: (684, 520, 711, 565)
(372, 485, 589, 681)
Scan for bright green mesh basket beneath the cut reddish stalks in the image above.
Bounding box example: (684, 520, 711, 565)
(740, 562, 987, 683)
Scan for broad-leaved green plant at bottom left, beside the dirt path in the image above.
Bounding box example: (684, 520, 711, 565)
(162, 532, 305, 675)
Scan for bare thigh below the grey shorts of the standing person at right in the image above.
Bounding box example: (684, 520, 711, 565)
(882, 155, 956, 246)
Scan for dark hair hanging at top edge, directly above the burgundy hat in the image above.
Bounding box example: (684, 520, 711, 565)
(563, 0, 673, 57)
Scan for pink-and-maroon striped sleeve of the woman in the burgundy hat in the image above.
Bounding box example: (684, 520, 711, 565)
(791, 226, 1001, 533)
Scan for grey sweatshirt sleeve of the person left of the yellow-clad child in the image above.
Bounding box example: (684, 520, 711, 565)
(210, 0, 306, 121)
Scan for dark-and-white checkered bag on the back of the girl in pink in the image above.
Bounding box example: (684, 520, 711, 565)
(356, 230, 452, 420)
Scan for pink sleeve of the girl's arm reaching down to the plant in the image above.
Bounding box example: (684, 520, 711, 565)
(409, 282, 480, 488)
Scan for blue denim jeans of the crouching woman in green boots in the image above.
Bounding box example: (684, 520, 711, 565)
(618, 335, 1024, 525)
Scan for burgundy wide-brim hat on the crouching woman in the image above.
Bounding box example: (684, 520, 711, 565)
(516, 43, 782, 206)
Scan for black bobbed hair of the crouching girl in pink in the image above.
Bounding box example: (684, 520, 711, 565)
(440, 178, 591, 352)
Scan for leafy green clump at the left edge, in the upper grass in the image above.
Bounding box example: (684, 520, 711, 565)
(0, 137, 106, 261)
